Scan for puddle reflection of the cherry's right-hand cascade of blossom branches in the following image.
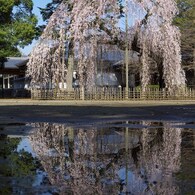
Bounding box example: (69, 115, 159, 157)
(140, 123, 181, 194)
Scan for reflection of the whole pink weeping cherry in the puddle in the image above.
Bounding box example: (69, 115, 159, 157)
(30, 123, 181, 194)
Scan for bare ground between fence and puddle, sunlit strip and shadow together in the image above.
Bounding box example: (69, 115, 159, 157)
(0, 99, 195, 124)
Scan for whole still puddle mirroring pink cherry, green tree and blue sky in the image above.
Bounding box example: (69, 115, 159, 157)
(0, 122, 195, 195)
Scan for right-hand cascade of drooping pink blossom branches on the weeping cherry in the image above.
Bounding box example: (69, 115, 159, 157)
(136, 0, 185, 92)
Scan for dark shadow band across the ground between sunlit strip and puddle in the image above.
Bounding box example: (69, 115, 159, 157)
(0, 103, 195, 123)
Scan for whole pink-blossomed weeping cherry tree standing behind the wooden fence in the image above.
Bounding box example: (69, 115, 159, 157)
(27, 0, 185, 92)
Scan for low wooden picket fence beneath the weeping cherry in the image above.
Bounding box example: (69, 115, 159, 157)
(31, 87, 195, 101)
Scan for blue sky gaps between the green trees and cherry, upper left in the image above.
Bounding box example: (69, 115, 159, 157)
(20, 0, 52, 55)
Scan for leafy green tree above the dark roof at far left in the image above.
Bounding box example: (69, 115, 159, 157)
(0, 0, 39, 67)
